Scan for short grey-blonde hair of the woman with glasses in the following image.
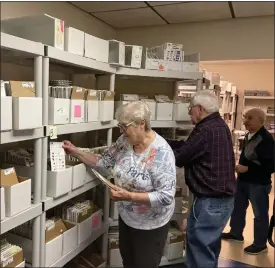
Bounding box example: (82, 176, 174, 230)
(115, 101, 151, 131)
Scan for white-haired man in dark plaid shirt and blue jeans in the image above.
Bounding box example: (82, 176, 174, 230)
(169, 90, 236, 268)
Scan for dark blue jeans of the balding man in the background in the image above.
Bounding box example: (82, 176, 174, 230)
(230, 181, 271, 247)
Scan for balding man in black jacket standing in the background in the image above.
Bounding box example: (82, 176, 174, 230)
(222, 108, 274, 255)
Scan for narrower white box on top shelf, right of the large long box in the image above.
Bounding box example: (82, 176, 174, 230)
(65, 27, 84, 56)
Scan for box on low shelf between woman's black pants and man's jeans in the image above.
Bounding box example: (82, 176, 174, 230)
(164, 229, 184, 260)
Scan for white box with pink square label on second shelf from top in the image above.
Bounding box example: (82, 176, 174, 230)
(70, 87, 86, 123)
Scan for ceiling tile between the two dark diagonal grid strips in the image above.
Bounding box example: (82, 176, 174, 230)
(154, 2, 231, 23)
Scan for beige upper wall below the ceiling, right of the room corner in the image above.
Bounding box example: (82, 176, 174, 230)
(117, 16, 274, 61)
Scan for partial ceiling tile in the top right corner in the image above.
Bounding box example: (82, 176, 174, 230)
(232, 1, 274, 18)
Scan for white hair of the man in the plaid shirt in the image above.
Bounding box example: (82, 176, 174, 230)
(190, 90, 220, 114)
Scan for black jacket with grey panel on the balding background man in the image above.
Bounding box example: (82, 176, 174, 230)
(238, 127, 274, 185)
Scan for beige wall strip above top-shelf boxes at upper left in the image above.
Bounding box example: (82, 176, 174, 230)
(1, 1, 116, 39)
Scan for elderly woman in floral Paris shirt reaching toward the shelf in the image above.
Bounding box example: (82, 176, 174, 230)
(64, 101, 176, 268)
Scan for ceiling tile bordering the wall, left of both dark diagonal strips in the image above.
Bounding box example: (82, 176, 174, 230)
(93, 8, 166, 28)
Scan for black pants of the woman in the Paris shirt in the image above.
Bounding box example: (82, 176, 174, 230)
(119, 218, 169, 268)
